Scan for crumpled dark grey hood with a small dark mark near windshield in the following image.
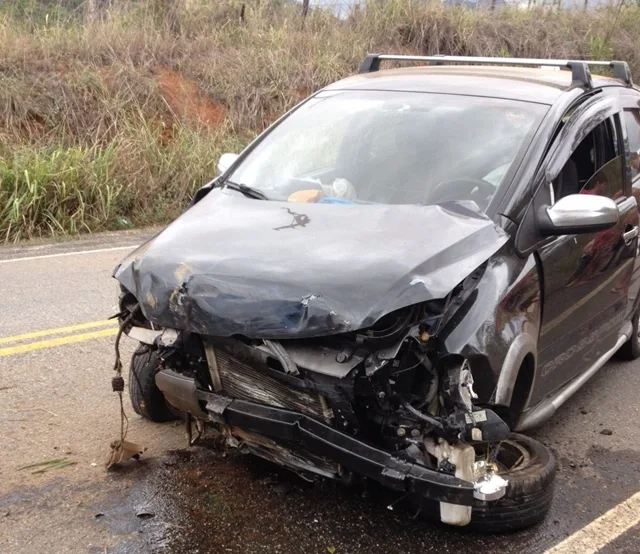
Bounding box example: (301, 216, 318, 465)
(114, 189, 507, 338)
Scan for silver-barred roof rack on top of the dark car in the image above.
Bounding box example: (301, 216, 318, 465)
(360, 54, 633, 88)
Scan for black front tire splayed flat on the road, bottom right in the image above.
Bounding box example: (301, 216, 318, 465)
(422, 433, 556, 533)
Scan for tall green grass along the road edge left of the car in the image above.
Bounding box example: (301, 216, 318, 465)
(0, 125, 246, 241)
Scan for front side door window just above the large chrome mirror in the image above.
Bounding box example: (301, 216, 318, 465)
(553, 118, 624, 200)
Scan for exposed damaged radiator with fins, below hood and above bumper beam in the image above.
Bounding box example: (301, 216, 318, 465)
(215, 350, 331, 421)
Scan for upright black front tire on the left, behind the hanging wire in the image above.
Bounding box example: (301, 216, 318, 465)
(129, 344, 178, 423)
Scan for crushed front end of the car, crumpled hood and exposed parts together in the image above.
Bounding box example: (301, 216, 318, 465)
(114, 189, 520, 525)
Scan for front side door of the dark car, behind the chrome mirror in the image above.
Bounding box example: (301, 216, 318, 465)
(532, 102, 638, 402)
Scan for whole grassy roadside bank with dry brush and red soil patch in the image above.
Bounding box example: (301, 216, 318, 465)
(0, 0, 640, 242)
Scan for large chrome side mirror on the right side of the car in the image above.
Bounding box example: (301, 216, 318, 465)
(537, 194, 620, 237)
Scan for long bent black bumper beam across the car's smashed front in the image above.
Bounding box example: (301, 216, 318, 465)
(197, 391, 474, 506)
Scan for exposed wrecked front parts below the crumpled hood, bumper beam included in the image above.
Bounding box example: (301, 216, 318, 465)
(121, 282, 509, 525)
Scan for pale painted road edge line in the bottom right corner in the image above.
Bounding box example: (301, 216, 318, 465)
(544, 492, 640, 554)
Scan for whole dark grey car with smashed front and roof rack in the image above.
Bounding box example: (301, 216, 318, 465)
(115, 55, 640, 532)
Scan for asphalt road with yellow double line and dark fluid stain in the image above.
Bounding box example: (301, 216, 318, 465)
(0, 233, 640, 554)
